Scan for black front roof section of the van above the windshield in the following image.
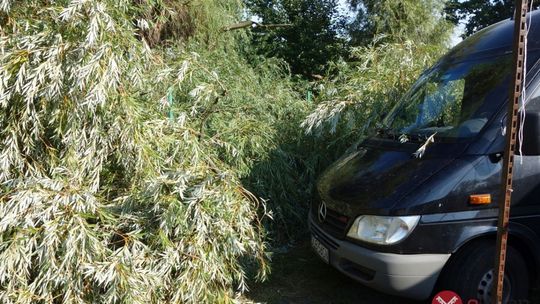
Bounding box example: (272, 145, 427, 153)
(447, 10, 540, 59)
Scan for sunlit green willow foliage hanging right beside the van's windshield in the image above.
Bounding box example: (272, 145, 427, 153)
(303, 0, 451, 146)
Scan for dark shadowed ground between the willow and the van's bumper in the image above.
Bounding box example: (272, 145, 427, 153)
(246, 242, 421, 304)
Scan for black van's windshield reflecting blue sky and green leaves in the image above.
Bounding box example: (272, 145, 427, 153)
(384, 54, 512, 139)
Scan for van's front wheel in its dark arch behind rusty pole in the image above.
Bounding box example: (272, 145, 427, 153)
(435, 240, 529, 304)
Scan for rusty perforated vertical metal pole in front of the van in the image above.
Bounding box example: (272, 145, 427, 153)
(493, 0, 527, 304)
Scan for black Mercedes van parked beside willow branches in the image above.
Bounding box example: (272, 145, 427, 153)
(309, 12, 540, 303)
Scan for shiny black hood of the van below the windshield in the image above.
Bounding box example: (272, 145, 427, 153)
(318, 140, 464, 216)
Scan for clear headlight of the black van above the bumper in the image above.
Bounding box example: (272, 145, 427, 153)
(347, 215, 420, 245)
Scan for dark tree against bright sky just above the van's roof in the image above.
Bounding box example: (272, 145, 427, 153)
(445, 0, 540, 38)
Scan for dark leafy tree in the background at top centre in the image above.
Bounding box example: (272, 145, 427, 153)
(246, 0, 347, 76)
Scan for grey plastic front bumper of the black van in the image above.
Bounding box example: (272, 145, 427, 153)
(309, 215, 450, 300)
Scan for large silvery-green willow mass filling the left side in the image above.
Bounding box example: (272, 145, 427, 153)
(0, 0, 312, 304)
